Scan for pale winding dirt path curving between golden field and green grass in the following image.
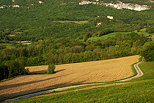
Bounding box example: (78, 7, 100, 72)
(5, 61, 143, 101)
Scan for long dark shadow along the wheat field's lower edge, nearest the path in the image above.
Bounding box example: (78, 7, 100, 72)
(0, 81, 84, 102)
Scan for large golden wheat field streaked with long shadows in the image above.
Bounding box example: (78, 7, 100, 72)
(0, 55, 139, 98)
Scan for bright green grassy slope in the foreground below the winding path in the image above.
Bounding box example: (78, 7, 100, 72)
(5, 59, 154, 103)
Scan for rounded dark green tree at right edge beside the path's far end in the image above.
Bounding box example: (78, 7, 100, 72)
(141, 41, 154, 61)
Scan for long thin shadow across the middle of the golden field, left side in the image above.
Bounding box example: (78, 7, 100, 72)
(0, 74, 69, 90)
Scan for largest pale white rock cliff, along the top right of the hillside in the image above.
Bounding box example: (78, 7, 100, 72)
(79, 0, 150, 11)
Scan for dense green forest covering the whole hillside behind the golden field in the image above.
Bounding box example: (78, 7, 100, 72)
(0, 0, 154, 79)
